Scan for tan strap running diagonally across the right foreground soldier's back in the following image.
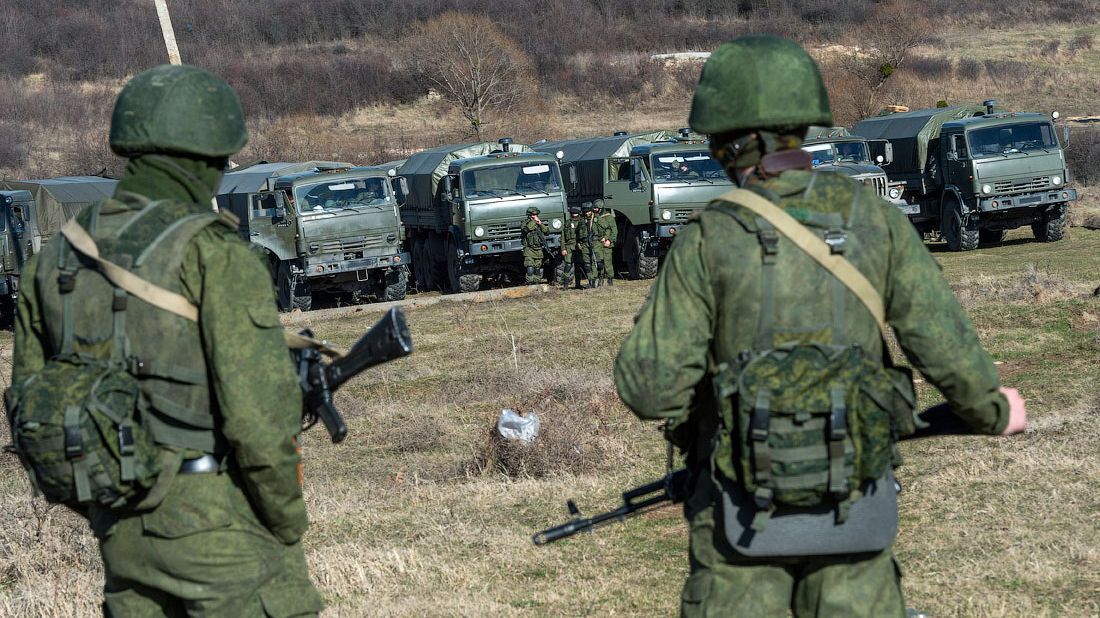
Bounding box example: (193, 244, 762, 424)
(718, 189, 887, 334)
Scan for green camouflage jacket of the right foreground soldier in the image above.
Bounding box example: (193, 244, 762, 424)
(615, 170, 1009, 461)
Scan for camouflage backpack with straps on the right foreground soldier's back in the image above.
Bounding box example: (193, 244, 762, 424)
(712, 184, 915, 536)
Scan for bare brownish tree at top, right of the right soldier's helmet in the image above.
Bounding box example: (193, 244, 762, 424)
(831, 0, 934, 120)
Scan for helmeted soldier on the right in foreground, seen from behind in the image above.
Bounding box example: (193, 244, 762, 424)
(615, 36, 1026, 617)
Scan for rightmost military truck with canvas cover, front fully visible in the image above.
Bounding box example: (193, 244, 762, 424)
(851, 100, 1077, 251)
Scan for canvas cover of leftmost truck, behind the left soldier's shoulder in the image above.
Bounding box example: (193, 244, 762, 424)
(0, 176, 119, 239)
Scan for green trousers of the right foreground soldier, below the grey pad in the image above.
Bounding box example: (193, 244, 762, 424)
(680, 472, 905, 618)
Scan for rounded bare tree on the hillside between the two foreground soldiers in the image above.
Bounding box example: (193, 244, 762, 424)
(409, 12, 535, 141)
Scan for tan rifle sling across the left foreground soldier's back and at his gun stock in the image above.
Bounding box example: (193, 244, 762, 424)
(62, 219, 344, 356)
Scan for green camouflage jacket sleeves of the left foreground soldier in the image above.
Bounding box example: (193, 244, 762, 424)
(12, 198, 308, 543)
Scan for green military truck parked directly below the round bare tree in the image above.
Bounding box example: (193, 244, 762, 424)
(397, 137, 565, 293)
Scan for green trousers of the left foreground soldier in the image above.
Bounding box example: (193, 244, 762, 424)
(90, 473, 323, 618)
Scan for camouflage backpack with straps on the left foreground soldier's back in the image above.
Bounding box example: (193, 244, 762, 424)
(6, 206, 217, 512)
